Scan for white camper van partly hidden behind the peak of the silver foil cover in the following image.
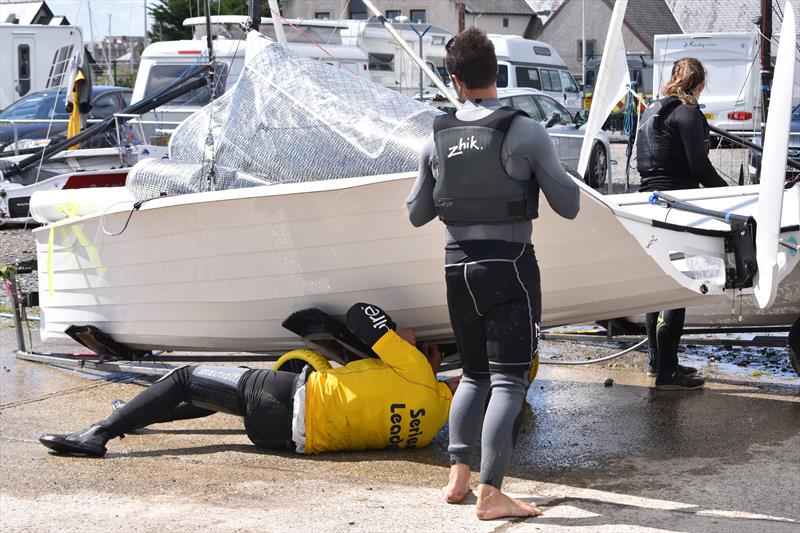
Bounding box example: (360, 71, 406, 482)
(132, 15, 369, 139)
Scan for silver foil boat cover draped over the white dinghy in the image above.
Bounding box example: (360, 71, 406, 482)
(127, 32, 440, 199)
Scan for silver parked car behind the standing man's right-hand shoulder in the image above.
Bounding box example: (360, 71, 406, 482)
(497, 88, 611, 189)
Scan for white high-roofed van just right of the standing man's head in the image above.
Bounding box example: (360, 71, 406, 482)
(489, 34, 582, 114)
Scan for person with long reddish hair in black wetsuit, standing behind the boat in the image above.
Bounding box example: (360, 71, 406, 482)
(636, 58, 727, 390)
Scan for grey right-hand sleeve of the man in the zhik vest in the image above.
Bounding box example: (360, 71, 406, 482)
(503, 117, 581, 219)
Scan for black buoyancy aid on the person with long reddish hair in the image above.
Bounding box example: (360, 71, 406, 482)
(636, 96, 691, 178)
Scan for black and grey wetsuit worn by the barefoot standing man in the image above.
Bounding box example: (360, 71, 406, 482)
(408, 99, 580, 487)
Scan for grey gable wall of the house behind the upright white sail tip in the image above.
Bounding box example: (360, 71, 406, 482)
(534, 0, 652, 82)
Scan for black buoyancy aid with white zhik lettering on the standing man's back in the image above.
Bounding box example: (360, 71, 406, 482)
(433, 107, 539, 226)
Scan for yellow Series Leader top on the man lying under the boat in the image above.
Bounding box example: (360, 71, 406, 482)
(305, 331, 453, 454)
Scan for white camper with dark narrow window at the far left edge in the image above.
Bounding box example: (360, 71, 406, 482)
(0, 23, 83, 111)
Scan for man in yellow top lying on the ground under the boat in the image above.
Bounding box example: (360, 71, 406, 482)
(39, 304, 458, 457)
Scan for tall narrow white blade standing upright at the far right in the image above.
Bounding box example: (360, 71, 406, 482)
(754, 0, 797, 309)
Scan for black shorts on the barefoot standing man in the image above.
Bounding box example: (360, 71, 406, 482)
(445, 241, 542, 379)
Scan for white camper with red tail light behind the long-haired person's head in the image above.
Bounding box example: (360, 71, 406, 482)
(653, 33, 761, 132)
